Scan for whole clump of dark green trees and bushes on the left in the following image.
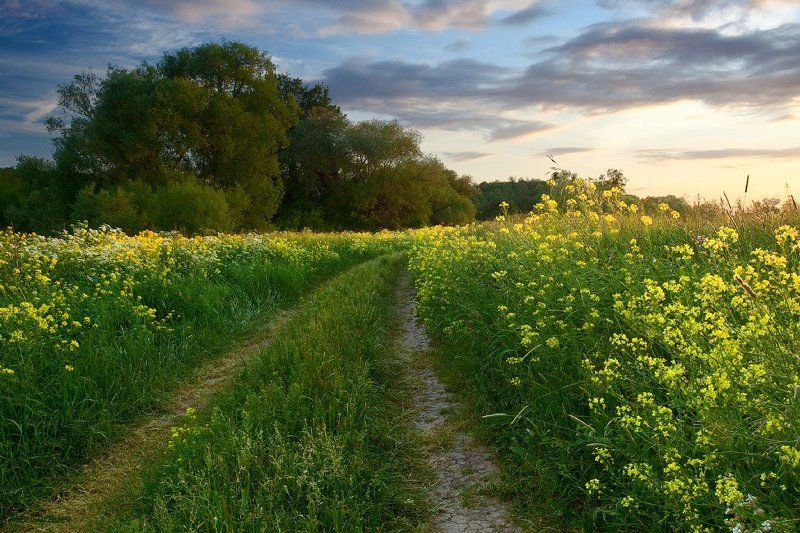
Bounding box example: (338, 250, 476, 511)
(0, 41, 476, 234)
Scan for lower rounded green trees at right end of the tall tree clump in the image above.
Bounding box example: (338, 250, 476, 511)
(280, 109, 474, 229)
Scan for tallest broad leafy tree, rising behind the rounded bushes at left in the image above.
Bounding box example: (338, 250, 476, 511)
(44, 42, 299, 229)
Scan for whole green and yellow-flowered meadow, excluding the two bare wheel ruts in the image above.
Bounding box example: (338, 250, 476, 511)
(0, 179, 800, 532)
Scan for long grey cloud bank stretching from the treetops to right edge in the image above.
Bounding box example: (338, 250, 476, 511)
(325, 22, 800, 126)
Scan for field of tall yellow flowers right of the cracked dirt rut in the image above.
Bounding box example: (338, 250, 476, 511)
(411, 180, 800, 532)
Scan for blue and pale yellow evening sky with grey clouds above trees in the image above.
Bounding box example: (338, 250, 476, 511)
(0, 0, 800, 199)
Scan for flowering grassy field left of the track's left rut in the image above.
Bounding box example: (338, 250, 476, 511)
(0, 227, 404, 519)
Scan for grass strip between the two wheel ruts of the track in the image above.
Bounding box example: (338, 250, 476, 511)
(117, 256, 425, 531)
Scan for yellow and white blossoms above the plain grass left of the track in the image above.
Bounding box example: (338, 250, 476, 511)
(0, 227, 400, 381)
